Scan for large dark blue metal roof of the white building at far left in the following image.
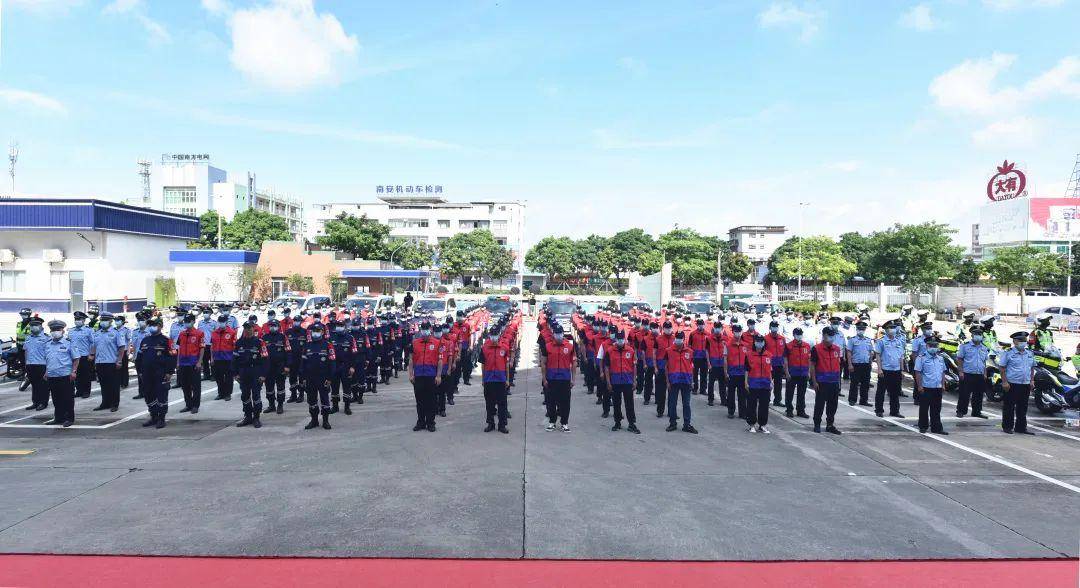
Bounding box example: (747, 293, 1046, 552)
(0, 198, 199, 239)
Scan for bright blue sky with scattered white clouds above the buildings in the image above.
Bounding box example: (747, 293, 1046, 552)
(0, 0, 1080, 242)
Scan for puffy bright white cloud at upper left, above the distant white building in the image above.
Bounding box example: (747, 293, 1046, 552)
(230, 0, 360, 92)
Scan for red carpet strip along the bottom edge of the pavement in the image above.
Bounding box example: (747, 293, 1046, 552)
(0, 556, 1080, 588)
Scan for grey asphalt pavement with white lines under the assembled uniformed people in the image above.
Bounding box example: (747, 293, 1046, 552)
(0, 323, 1080, 560)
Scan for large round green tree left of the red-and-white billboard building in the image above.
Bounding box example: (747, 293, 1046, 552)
(866, 222, 963, 292)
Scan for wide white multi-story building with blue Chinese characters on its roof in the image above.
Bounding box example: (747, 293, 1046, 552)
(308, 195, 525, 272)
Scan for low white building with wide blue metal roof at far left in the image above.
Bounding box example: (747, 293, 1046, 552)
(0, 198, 199, 313)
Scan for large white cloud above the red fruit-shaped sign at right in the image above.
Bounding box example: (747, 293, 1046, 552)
(930, 53, 1080, 116)
